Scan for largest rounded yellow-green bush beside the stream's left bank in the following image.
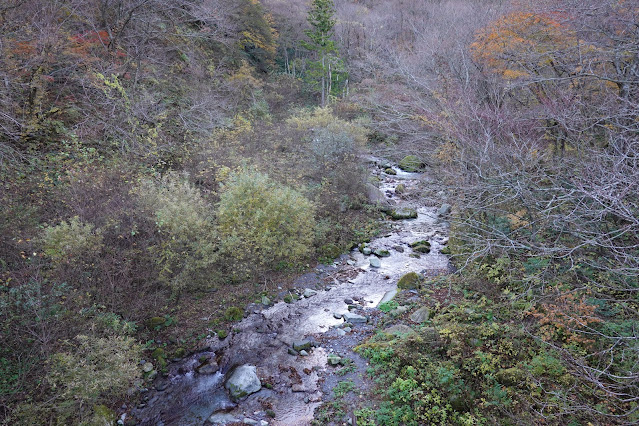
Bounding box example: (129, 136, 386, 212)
(217, 171, 315, 278)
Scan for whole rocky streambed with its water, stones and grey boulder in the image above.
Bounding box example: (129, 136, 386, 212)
(129, 158, 450, 426)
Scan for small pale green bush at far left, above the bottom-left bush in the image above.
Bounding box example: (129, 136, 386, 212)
(42, 216, 102, 264)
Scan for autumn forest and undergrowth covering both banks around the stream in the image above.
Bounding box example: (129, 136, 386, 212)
(0, 0, 639, 425)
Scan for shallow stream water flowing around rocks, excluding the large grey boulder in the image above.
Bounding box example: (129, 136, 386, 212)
(132, 159, 449, 426)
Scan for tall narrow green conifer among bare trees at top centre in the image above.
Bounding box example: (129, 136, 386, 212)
(304, 0, 345, 107)
